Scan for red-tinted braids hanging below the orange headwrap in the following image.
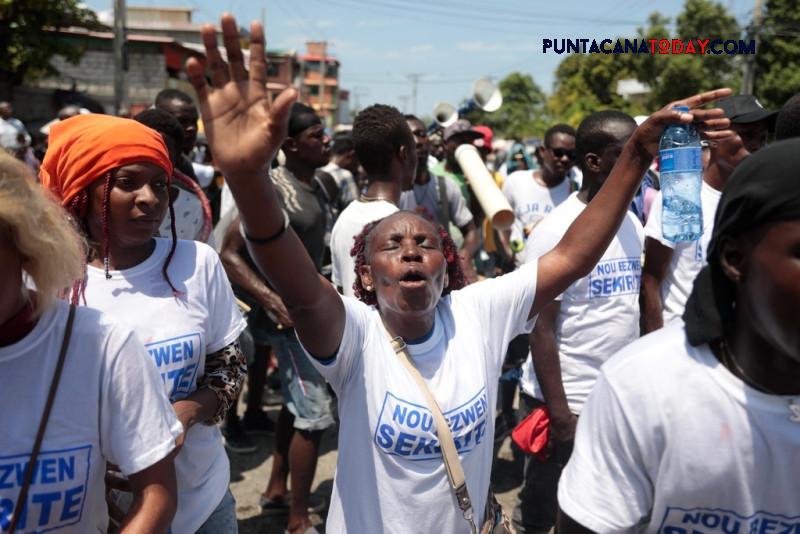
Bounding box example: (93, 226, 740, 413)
(64, 172, 180, 305)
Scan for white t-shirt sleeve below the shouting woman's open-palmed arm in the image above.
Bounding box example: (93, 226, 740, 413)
(300, 297, 370, 394)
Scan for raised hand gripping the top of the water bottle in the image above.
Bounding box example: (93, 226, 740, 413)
(631, 89, 735, 158)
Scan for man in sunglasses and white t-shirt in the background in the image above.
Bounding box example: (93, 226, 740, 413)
(503, 124, 575, 251)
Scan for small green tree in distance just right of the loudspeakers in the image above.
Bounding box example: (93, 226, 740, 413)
(466, 72, 547, 139)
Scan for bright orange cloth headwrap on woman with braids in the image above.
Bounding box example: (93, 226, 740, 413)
(39, 114, 172, 206)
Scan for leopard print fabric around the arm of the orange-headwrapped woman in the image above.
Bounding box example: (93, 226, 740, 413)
(197, 341, 247, 425)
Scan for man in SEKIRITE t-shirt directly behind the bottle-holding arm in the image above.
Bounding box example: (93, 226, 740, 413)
(514, 111, 644, 533)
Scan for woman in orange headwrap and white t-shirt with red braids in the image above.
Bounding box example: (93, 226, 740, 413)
(41, 115, 245, 534)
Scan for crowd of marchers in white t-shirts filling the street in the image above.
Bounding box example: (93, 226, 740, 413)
(0, 15, 800, 534)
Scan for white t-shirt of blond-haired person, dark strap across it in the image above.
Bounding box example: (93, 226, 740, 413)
(0, 301, 183, 534)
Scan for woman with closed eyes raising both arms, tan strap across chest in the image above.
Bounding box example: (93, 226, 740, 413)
(188, 15, 731, 533)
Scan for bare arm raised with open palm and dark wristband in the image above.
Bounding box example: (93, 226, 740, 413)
(186, 14, 344, 357)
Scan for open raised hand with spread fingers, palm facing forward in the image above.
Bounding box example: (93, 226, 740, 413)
(186, 13, 297, 181)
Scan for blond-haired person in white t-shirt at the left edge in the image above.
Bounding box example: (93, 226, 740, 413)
(0, 154, 182, 533)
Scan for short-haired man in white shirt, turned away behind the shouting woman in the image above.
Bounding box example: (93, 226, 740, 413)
(331, 104, 424, 297)
